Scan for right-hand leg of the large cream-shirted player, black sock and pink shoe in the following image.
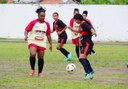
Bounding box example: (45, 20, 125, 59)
(38, 50, 45, 77)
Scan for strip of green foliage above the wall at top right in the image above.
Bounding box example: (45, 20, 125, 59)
(80, 0, 128, 5)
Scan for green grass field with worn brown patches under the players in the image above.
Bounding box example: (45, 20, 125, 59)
(0, 42, 128, 89)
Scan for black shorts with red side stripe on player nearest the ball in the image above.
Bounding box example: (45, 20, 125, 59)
(80, 42, 93, 55)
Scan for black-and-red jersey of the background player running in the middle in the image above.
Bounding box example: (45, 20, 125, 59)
(53, 19, 67, 38)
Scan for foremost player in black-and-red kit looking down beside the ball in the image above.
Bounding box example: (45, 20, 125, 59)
(70, 14, 96, 80)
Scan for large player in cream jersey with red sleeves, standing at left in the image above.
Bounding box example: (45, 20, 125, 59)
(24, 7, 52, 77)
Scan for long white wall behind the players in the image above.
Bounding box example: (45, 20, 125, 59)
(0, 4, 128, 41)
